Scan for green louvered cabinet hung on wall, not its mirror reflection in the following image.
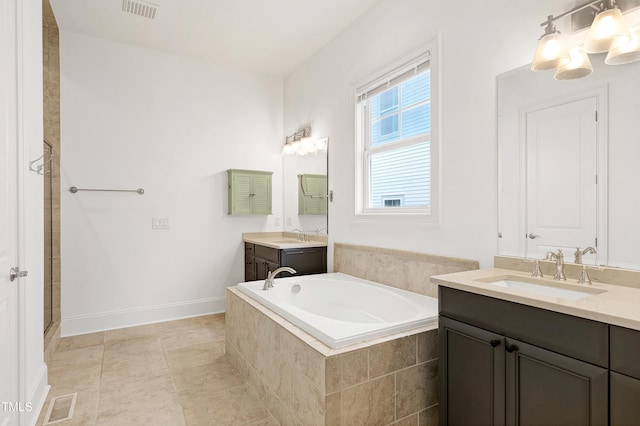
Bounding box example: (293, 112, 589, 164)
(227, 169, 273, 215)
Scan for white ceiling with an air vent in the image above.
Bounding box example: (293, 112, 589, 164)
(51, 0, 378, 76)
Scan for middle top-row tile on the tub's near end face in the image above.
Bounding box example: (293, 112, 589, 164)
(369, 335, 417, 378)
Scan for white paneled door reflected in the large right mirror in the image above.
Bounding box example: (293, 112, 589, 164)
(525, 97, 598, 262)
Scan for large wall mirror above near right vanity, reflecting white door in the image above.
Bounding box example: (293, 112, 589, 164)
(497, 55, 640, 269)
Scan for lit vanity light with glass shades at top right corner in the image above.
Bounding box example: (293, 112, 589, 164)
(531, 0, 640, 80)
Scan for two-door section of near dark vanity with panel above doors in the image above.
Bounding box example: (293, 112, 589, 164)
(439, 286, 609, 425)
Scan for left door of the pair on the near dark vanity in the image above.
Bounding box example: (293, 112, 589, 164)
(438, 317, 505, 426)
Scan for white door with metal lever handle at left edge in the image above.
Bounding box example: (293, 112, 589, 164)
(0, 0, 19, 426)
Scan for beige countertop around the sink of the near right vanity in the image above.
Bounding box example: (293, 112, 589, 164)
(431, 268, 640, 330)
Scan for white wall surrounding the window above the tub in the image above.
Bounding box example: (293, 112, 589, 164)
(284, 0, 570, 267)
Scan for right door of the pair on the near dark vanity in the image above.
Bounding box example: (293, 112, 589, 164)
(505, 338, 609, 426)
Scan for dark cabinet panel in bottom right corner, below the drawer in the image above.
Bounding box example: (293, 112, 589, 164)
(610, 371, 640, 426)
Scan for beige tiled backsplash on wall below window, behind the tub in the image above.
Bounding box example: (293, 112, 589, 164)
(333, 243, 480, 297)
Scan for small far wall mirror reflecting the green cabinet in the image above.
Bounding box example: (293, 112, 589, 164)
(283, 141, 328, 235)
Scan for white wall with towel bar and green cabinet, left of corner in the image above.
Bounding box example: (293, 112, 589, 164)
(60, 31, 283, 336)
